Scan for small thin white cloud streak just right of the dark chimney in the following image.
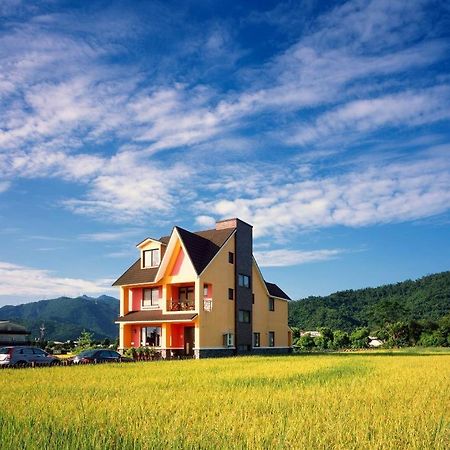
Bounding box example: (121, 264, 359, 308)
(254, 249, 344, 267)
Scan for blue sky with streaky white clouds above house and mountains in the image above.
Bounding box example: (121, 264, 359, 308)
(0, 0, 450, 305)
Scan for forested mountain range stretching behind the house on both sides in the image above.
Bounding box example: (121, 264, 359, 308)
(0, 271, 450, 341)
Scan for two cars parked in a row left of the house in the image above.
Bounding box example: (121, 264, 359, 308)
(0, 346, 133, 367)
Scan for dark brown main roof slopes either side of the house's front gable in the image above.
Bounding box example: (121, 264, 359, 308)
(113, 227, 235, 286)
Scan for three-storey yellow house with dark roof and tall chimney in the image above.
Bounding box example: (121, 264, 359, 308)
(114, 219, 292, 358)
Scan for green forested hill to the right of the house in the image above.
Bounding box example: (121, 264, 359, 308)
(289, 272, 450, 331)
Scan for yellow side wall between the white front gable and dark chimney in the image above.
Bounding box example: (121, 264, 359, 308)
(199, 234, 236, 349)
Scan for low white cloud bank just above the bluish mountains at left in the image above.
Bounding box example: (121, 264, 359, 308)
(0, 262, 116, 299)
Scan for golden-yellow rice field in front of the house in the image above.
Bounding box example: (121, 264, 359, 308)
(0, 353, 450, 450)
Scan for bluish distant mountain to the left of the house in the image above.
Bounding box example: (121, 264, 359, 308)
(0, 295, 119, 341)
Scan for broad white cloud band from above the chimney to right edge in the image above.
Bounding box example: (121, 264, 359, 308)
(197, 149, 450, 236)
